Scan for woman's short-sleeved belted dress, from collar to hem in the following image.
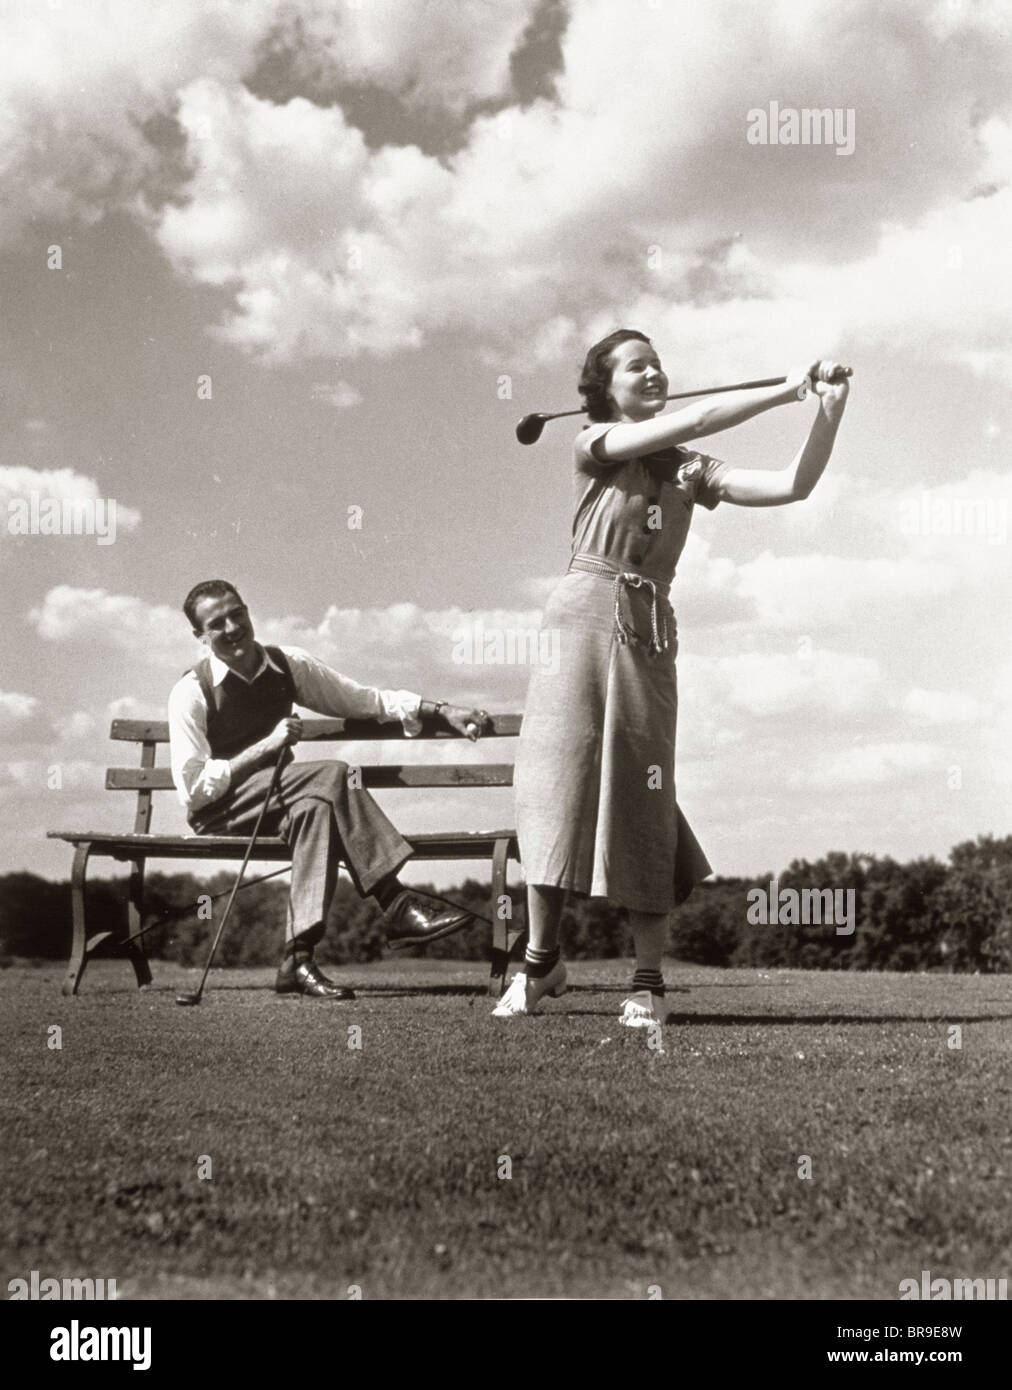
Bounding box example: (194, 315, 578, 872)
(514, 424, 727, 913)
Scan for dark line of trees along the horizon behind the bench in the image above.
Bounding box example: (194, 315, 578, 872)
(0, 835, 1012, 973)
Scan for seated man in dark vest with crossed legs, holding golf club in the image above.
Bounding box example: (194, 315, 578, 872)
(168, 580, 488, 999)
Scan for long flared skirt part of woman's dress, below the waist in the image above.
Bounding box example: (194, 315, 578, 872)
(514, 570, 712, 912)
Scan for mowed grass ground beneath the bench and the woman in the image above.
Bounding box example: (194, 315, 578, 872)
(0, 960, 1012, 1300)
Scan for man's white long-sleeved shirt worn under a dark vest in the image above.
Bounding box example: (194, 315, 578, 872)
(168, 646, 421, 812)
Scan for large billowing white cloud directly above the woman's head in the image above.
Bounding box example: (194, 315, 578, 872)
(142, 0, 1008, 374)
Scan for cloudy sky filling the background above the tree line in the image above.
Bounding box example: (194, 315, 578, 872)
(0, 0, 1012, 881)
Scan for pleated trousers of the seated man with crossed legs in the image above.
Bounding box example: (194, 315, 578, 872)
(190, 762, 411, 944)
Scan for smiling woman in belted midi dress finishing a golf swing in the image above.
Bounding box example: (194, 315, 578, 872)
(493, 329, 848, 1027)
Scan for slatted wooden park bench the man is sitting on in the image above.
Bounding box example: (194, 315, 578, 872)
(47, 714, 525, 995)
